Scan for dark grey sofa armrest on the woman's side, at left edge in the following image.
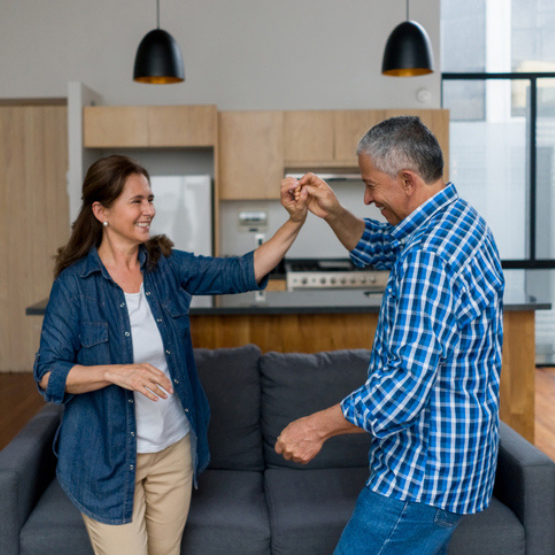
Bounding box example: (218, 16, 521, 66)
(0, 403, 63, 555)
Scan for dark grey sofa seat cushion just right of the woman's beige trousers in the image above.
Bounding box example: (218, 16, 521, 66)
(185, 470, 270, 555)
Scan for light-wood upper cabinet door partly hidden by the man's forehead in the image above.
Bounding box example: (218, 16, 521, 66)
(334, 110, 386, 164)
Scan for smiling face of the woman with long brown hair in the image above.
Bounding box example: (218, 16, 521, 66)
(103, 173, 156, 245)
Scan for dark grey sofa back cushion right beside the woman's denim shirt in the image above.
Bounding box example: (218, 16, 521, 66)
(194, 345, 264, 471)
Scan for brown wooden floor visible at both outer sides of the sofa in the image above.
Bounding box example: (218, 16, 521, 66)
(0, 368, 555, 460)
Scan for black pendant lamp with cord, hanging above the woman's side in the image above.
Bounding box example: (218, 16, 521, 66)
(133, 0, 185, 85)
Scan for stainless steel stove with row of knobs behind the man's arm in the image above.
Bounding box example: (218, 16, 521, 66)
(284, 258, 389, 293)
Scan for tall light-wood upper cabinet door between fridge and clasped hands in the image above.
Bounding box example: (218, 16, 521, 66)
(219, 111, 284, 200)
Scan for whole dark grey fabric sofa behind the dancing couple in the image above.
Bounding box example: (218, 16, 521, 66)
(0, 345, 555, 555)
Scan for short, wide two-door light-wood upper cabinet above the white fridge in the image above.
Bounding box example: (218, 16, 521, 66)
(83, 105, 217, 148)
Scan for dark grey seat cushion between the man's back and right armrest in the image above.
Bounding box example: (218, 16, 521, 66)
(449, 497, 526, 555)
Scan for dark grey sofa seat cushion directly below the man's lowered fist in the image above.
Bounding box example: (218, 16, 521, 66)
(264, 468, 368, 555)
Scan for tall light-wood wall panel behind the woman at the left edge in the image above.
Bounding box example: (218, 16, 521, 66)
(0, 105, 69, 372)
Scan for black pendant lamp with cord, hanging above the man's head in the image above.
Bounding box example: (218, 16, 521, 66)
(382, 0, 434, 77)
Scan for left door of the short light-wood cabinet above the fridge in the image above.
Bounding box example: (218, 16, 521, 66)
(83, 106, 149, 148)
